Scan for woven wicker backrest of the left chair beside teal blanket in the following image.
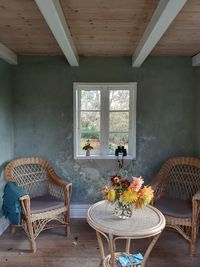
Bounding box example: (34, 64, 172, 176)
(5, 157, 51, 197)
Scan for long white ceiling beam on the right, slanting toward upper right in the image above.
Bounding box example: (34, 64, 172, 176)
(132, 0, 187, 67)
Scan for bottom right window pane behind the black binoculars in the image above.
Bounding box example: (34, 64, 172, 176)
(109, 133, 128, 154)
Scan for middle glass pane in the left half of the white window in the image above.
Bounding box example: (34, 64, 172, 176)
(80, 111, 100, 132)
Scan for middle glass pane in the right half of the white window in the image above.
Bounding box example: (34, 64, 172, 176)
(109, 112, 129, 132)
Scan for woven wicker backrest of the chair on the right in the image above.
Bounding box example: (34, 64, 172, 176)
(160, 157, 200, 200)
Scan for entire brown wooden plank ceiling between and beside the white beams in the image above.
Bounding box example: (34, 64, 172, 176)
(0, 0, 200, 56)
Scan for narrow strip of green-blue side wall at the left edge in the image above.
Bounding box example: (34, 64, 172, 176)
(0, 60, 13, 218)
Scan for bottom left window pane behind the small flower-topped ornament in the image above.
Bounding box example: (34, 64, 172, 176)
(80, 136, 100, 155)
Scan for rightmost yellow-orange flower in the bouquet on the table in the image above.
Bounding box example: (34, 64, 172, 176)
(136, 186, 153, 208)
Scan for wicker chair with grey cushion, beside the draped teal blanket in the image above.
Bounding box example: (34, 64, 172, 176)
(5, 157, 72, 252)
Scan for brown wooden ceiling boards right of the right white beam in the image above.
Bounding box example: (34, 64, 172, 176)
(152, 0, 200, 56)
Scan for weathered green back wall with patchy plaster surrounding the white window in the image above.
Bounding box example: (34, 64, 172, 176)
(14, 56, 195, 203)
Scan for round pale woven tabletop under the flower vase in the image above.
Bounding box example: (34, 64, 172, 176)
(87, 200, 165, 239)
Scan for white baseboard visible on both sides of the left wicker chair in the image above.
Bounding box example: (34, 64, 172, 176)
(0, 204, 90, 235)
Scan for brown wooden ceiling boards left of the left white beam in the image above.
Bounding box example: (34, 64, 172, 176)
(0, 0, 62, 55)
